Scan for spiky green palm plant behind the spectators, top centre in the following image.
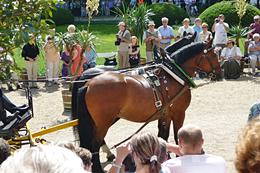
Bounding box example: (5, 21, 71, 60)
(115, 4, 154, 43)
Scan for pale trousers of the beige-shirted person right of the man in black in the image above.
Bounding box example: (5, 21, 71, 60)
(46, 60, 60, 81)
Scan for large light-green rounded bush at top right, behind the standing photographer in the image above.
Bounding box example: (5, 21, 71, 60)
(199, 1, 260, 27)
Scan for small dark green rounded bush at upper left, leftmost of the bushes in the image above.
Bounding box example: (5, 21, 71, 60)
(52, 8, 74, 25)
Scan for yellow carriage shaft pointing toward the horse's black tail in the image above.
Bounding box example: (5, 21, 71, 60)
(8, 119, 78, 145)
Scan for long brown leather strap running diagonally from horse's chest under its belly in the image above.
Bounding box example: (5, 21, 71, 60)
(107, 85, 189, 150)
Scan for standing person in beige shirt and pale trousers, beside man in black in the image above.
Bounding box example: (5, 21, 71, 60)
(43, 36, 60, 87)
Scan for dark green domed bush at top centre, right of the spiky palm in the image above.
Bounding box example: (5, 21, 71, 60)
(150, 3, 188, 27)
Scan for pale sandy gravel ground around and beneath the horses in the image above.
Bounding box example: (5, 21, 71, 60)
(3, 76, 260, 173)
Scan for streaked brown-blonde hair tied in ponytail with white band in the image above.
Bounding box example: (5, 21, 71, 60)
(131, 132, 161, 173)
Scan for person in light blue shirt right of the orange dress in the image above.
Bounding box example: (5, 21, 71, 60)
(83, 45, 97, 70)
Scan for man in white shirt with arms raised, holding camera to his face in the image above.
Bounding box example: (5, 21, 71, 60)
(212, 14, 229, 48)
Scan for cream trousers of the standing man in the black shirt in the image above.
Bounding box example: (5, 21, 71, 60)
(26, 60, 38, 87)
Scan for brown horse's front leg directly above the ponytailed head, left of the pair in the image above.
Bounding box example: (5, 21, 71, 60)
(158, 114, 171, 141)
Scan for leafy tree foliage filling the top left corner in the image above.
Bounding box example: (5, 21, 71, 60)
(0, 0, 58, 82)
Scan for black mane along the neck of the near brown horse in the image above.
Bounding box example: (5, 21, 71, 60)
(171, 42, 206, 65)
